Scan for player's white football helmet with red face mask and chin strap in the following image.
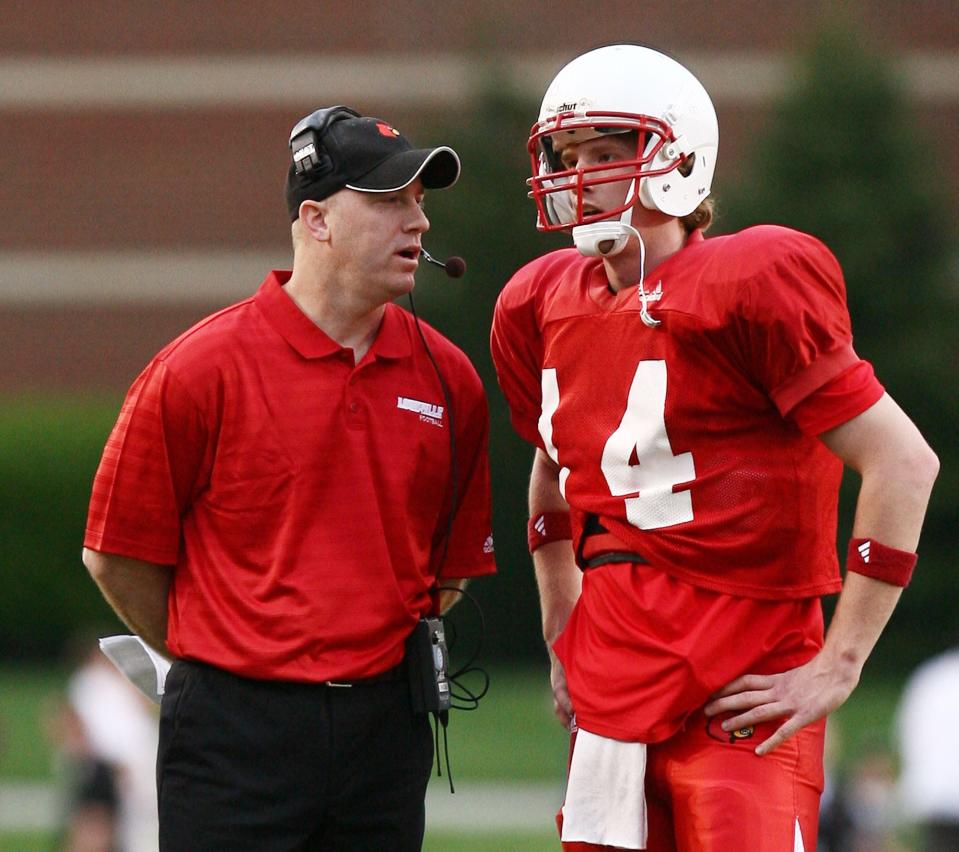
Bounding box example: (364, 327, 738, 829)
(527, 44, 719, 255)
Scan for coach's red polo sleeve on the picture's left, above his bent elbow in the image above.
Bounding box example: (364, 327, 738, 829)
(84, 359, 209, 565)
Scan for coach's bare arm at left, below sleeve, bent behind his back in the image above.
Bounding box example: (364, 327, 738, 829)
(83, 548, 172, 656)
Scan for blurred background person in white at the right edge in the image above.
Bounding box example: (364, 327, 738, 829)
(895, 641, 959, 852)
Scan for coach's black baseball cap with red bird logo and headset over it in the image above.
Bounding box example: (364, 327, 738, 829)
(286, 106, 460, 221)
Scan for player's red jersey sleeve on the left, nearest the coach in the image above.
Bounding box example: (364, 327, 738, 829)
(490, 268, 543, 448)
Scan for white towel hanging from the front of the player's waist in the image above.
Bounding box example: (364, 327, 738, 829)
(562, 728, 646, 849)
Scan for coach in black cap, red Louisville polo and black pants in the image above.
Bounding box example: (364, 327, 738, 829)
(83, 107, 494, 852)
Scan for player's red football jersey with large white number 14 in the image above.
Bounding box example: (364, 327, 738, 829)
(492, 226, 883, 599)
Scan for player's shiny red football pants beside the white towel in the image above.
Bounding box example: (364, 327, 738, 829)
(556, 712, 826, 852)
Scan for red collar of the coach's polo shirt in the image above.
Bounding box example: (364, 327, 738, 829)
(254, 269, 410, 358)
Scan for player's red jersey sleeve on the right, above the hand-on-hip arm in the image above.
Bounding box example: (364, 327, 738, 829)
(743, 232, 875, 429)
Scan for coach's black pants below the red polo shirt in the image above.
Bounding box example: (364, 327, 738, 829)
(157, 661, 433, 852)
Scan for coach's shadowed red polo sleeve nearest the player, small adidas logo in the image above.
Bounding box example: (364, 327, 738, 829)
(440, 356, 496, 579)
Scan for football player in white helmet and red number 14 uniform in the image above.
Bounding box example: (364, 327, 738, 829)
(492, 45, 938, 852)
